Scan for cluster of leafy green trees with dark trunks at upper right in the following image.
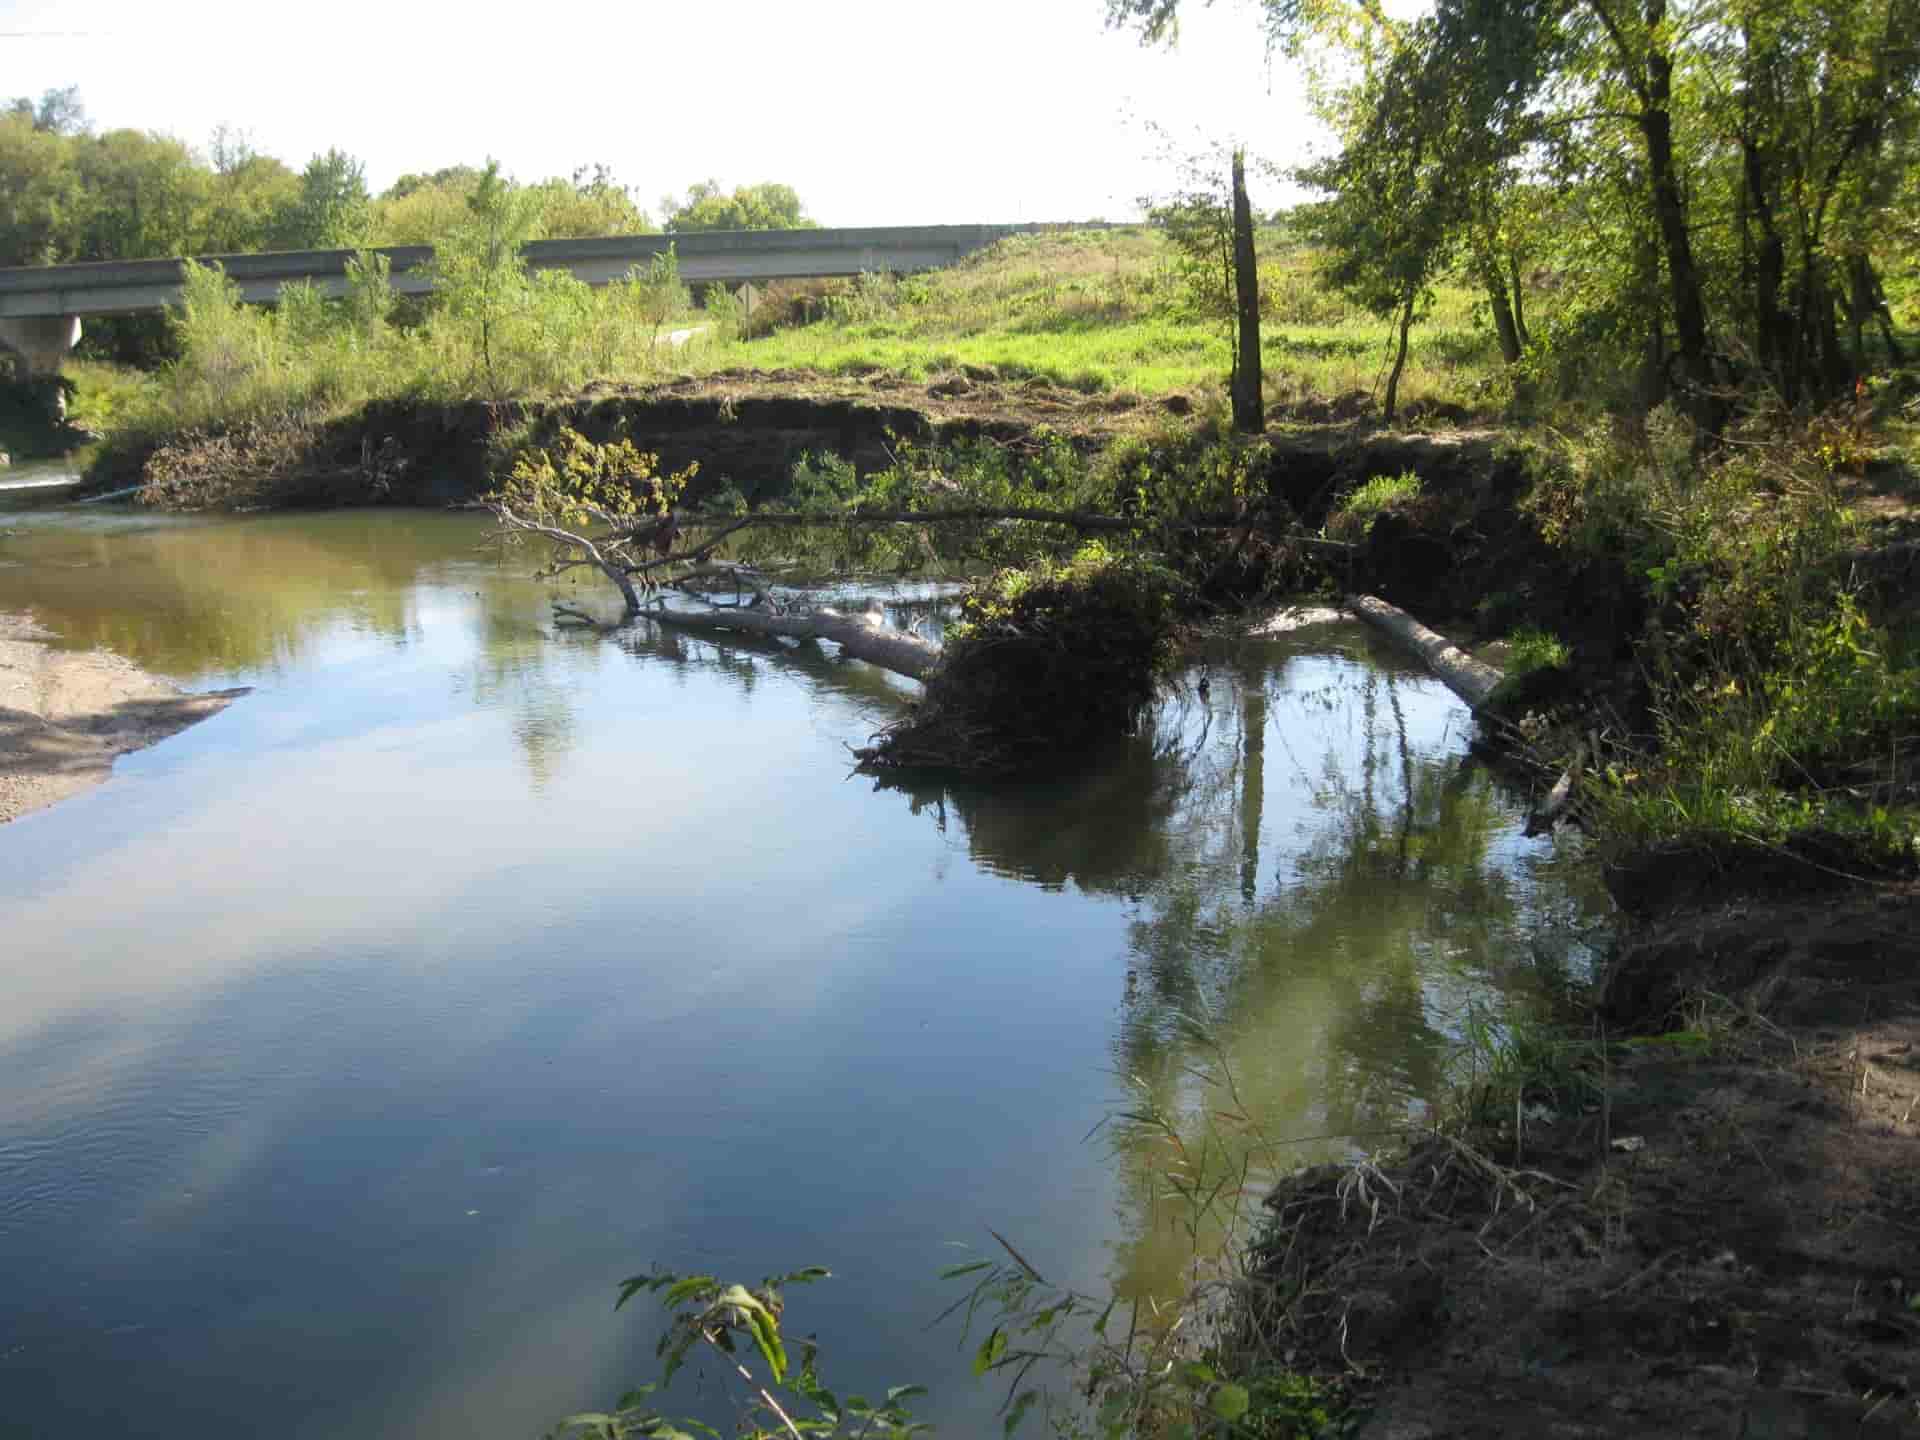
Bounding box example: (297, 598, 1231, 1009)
(1108, 0, 1920, 422)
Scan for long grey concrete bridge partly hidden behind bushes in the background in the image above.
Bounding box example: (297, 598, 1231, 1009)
(0, 225, 1058, 374)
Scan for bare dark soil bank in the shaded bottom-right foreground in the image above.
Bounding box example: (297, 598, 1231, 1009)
(1263, 885, 1920, 1440)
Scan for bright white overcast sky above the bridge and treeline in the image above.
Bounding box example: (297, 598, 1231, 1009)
(0, 0, 1315, 225)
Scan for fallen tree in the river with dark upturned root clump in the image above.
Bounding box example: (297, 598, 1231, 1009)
(484, 436, 1198, 772)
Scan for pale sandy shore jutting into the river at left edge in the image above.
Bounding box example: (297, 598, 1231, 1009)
(0, 614, 246, 824)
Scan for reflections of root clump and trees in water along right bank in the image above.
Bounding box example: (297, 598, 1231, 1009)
(864, 641, 1576, 1296)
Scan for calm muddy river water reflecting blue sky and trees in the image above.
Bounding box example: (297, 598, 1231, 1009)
(0, 505, 1590, 1440)
